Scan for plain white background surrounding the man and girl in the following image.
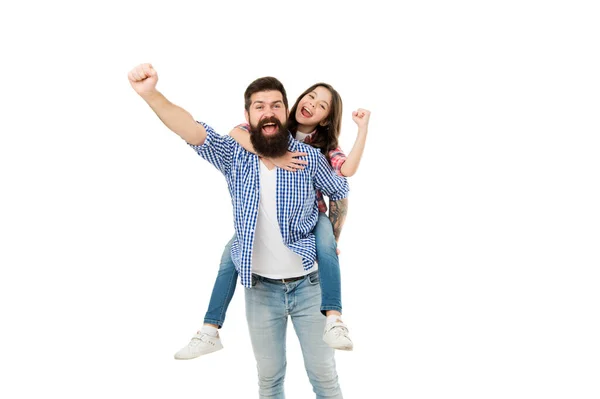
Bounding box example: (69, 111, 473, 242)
(0, 0, 600, 399)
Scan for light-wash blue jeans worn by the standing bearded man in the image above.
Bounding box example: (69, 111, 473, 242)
(245, 271, 342, 399)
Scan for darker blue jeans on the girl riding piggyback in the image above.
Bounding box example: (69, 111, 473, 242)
(204, 212, 342, 327)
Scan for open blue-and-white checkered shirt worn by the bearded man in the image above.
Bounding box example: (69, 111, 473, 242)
(190, 122, 349, 288)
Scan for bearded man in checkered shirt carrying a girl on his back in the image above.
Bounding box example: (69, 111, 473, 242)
(129, 64, 348, 398)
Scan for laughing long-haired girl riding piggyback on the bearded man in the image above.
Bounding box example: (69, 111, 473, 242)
(175, 83, 370, 359)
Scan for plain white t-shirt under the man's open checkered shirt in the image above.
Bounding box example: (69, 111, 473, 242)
(252, 161, 317, 279)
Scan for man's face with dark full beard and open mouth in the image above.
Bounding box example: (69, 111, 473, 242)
(246, 91, 289, 158)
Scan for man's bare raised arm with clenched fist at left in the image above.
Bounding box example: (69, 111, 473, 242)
(128, 64, 206, 145)
